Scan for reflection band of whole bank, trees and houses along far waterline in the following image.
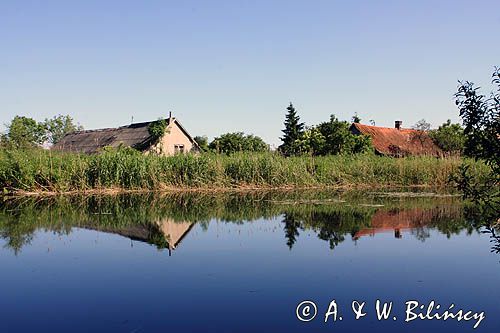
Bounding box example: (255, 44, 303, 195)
(0, 192, 500, 254)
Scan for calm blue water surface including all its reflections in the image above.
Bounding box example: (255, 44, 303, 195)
(0, 192, 500, 332)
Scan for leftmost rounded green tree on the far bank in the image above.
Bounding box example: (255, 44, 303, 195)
(7, 116, 46, 148)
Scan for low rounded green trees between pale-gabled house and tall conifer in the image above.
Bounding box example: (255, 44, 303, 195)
(209, 132, 269, 154)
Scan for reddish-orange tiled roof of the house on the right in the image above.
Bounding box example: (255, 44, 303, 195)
(351, 123, 442, 156)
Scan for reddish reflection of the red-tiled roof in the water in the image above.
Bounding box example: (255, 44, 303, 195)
(353, 208, 453, 240)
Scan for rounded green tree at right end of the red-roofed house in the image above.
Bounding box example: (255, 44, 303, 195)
(429, 119, 465, 155)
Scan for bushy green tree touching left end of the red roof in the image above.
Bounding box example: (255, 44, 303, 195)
(318, 115, 371, 155)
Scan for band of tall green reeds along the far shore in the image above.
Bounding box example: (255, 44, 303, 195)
(0, 149, 489, 193)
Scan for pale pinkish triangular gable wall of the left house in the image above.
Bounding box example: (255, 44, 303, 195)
(151, 120, 197, 156)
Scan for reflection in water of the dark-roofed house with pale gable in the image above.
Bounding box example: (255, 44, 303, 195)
(87, 218, 194, 254)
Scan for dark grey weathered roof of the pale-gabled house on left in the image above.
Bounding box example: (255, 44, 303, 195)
(52, 118, 196, 154)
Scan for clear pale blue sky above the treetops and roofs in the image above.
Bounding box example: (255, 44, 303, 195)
(0, 0, 500, 144)
